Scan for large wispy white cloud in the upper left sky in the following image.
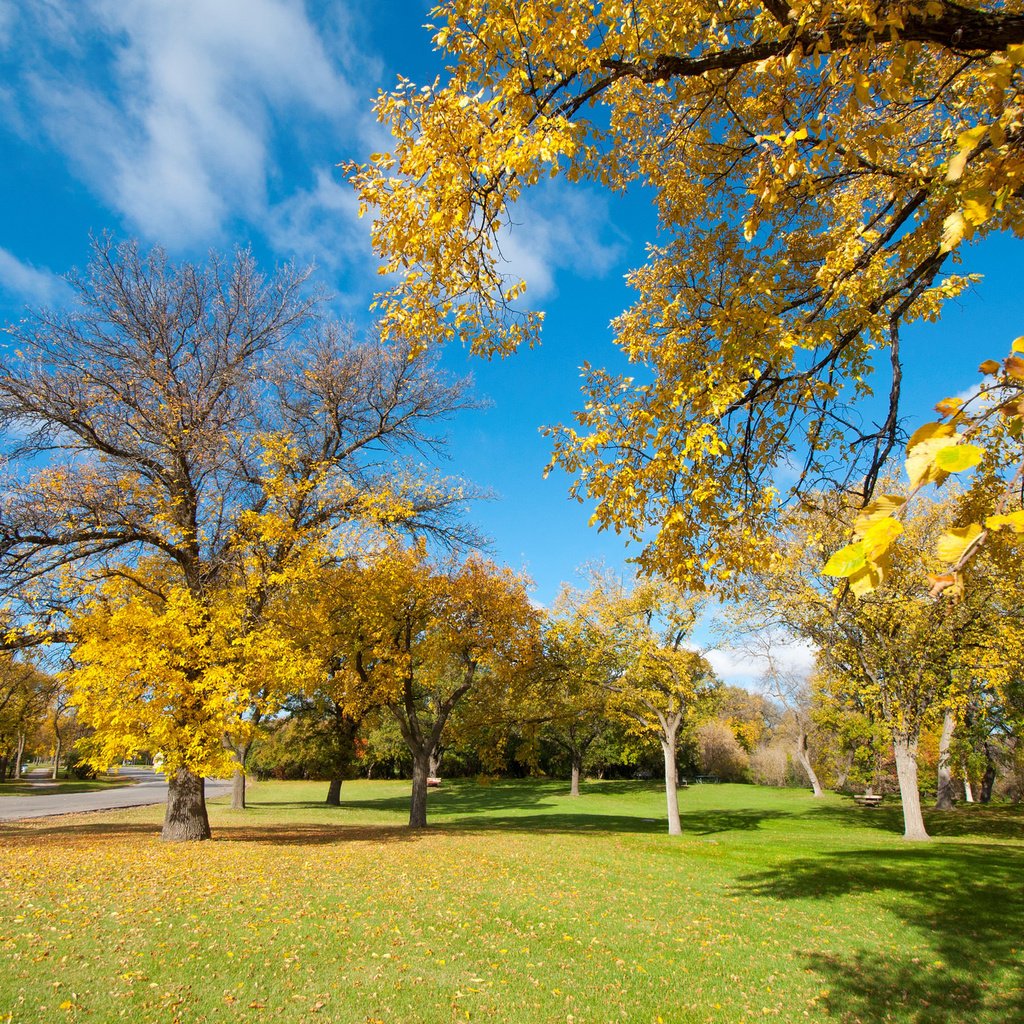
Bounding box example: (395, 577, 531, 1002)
(14, 0, 357, 246)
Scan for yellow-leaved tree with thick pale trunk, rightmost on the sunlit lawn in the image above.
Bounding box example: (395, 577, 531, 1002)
(750, 499, 1012, 840)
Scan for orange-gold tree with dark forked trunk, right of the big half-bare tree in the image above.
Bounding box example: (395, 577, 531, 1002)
(323, 545, 537, 828)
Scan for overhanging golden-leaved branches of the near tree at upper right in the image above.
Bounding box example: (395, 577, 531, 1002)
(350, 0, 1024, 585)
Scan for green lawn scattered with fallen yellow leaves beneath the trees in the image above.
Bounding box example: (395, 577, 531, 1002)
(0, 781, 1024, 1024)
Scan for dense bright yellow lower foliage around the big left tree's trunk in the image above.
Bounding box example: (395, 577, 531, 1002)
(66, 566, 316, 776)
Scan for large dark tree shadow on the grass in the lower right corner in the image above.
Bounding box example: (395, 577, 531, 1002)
(738, 844, 1024, 1024)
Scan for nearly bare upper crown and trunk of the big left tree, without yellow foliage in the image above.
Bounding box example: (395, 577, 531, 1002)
(0, 240, 479, 840)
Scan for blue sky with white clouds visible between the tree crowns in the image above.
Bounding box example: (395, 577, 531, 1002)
(0, 0, 1024, 678)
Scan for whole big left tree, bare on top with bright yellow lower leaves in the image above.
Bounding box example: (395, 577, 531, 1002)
(0, 241, 477, 839)
